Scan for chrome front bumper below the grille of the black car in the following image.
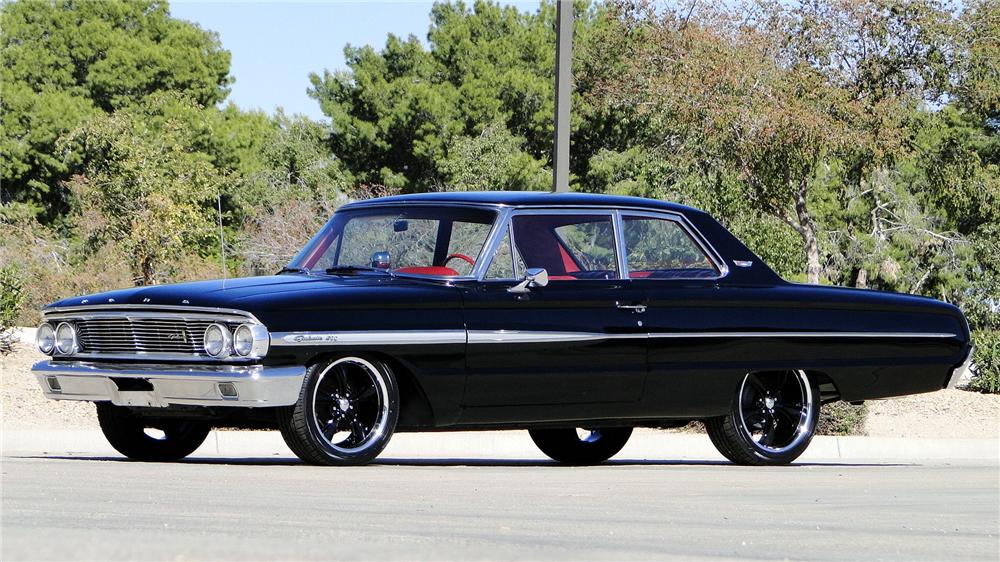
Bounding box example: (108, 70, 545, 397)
(31, 361, 305, 407)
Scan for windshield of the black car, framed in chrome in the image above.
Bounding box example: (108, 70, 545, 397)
(288, 207, 496, 277)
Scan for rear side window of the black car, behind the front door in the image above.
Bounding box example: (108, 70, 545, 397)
(623, 216, 719, 279)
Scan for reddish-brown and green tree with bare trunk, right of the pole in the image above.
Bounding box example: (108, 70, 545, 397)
(590, 0, 951, 283)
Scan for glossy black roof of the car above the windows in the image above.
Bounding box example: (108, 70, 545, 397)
(349, 191, 702, 213)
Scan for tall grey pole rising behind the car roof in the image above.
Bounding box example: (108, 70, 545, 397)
(552, 0, 573, 192)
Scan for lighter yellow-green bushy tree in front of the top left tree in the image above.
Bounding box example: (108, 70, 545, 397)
(61, 95, 227, 285)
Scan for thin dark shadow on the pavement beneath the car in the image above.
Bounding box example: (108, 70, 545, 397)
(11, 454, 920, 470)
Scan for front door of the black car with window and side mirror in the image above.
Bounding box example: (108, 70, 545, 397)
(464, 211, 646, 415)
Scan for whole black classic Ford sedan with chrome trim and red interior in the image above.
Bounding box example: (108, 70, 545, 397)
(33, 192, 971, 465)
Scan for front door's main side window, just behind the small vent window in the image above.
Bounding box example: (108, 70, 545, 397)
(512, 214, 618, 280)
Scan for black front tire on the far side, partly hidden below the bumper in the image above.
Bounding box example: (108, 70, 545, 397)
(97, 402, 212, 462)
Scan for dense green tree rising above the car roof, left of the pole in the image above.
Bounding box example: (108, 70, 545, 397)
(311, 1, 555, 191)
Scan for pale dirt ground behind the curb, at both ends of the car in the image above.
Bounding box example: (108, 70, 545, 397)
(0, 344, 1000, 439)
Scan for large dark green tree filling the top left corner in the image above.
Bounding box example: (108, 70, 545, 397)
(0, 0, 230, 221)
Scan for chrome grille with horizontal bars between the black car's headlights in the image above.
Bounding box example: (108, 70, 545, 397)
(74, 317, 212, 355)
